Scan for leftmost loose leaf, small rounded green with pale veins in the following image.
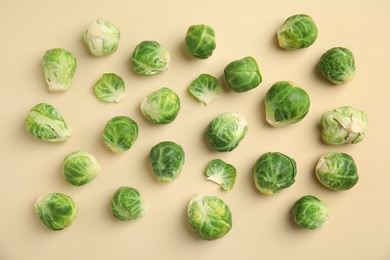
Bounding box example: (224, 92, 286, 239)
(93, 73, 126, 103)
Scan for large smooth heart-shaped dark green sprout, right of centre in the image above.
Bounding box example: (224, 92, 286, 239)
(265, 81, 310, 127)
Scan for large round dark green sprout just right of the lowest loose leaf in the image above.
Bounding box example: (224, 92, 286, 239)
(253, 152, 297, 195)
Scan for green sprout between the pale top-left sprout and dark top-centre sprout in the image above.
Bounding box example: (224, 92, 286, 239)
(131, 41, 170, 76)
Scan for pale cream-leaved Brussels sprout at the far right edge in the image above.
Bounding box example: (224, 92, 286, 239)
(321, 106, 368, 145)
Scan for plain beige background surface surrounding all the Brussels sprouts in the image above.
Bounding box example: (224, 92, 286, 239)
(0, 0, 390, 260)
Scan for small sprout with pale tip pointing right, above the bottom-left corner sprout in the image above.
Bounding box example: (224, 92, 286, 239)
(62, 150, 102, 186)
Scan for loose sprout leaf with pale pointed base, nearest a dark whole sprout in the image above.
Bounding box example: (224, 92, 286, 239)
(188, 74, 221, 105)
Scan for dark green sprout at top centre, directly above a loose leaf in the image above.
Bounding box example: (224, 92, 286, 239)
(185, 24, 217, 59)
